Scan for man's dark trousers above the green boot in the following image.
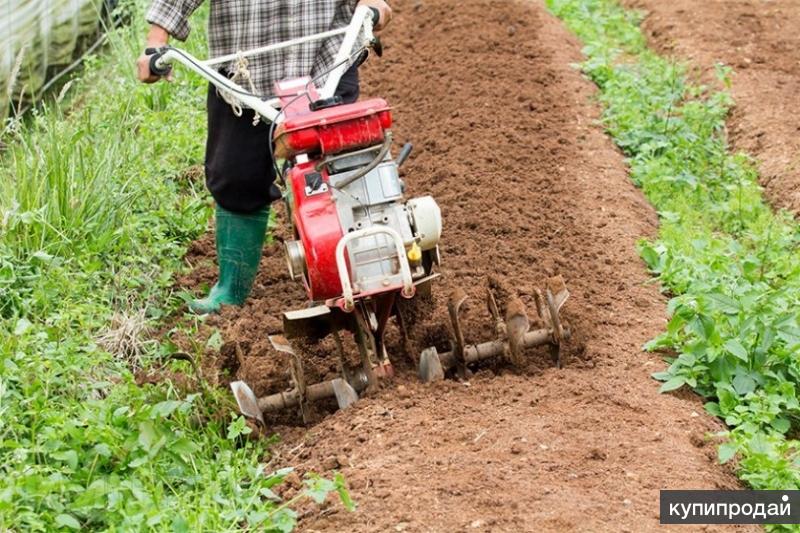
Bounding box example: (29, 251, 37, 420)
(206, 65, 359, 213)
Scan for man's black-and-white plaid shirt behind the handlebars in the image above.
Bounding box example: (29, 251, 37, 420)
(146, 0, 357, 96)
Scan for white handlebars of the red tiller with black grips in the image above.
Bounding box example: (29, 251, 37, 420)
(145, 6, 380, 122)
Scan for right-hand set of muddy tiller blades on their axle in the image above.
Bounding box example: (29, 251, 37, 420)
(419, 276, 570, 383)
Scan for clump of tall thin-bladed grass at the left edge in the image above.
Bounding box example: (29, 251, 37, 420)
(0, 105, 138, 255)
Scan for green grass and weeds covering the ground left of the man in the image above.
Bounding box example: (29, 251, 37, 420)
(0, 4, 352, 531)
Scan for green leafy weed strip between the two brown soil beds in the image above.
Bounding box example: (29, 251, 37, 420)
(547, 0, 800, 489)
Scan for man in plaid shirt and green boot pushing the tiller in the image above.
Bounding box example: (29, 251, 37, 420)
(137, 0, 392, 314)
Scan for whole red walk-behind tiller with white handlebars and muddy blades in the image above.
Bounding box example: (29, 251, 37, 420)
(150, 3, 569, 422)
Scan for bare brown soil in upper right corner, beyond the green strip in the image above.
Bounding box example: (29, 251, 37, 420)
(623, 0, 800, 215)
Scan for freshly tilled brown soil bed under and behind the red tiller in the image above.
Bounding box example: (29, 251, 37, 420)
(169, 0, 756, 531)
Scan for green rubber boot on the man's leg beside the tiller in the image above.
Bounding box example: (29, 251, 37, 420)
(189, 206, 269, 315)
